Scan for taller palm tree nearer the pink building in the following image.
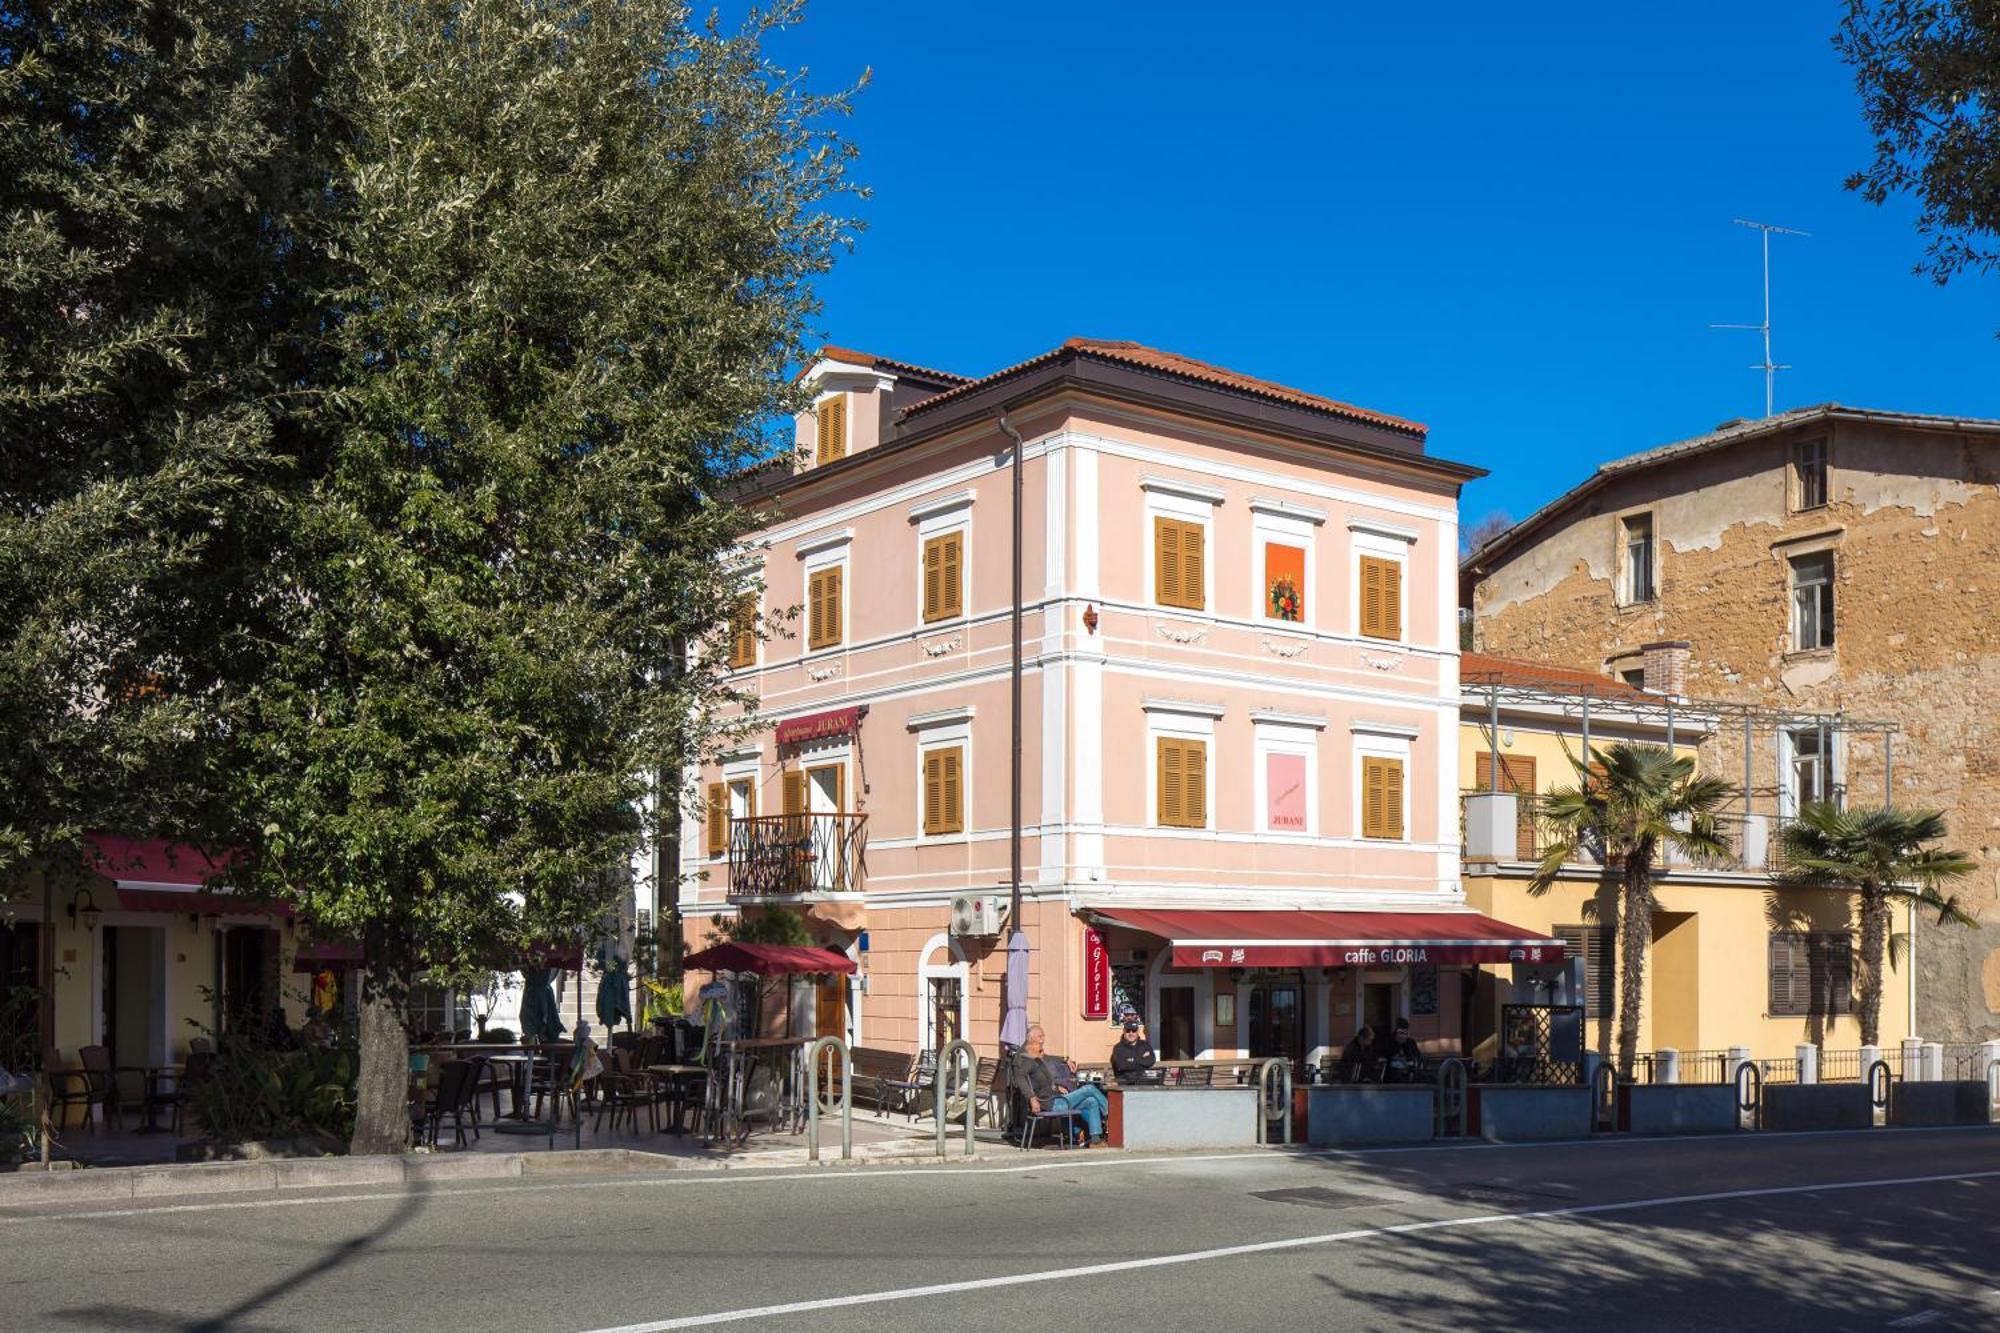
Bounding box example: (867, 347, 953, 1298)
(1528, 743, 1736, 1079)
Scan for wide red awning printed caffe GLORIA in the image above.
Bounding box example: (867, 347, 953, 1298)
(1096, 907, 1562, 967)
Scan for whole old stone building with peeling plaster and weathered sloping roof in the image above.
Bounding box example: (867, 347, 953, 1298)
(1460, 404, 2000, 1041)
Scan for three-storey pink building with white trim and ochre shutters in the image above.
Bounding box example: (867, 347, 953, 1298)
(680, 338, 1560, 1059)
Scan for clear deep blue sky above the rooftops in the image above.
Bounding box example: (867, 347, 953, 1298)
(774, 0, 2000, 520)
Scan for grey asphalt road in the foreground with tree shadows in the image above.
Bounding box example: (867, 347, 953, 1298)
(0, 1129, 2000, 1333)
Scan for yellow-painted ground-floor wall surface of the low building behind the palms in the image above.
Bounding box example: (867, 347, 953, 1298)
(1466, 875, 1914, 1059)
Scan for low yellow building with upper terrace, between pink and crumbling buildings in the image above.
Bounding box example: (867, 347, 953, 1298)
(1458, 644, 1916, 1077)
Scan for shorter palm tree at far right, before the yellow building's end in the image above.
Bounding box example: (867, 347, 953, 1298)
(1778, 801, 1978, 1047)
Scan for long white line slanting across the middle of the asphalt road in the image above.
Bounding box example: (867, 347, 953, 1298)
(588, 1171, 2000, 1333)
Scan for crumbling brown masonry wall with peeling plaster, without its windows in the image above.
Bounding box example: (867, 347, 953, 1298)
(1472, 424, 2000, 1041)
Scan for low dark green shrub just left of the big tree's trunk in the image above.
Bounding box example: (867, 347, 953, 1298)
(186, 1039, 358, 1147)
